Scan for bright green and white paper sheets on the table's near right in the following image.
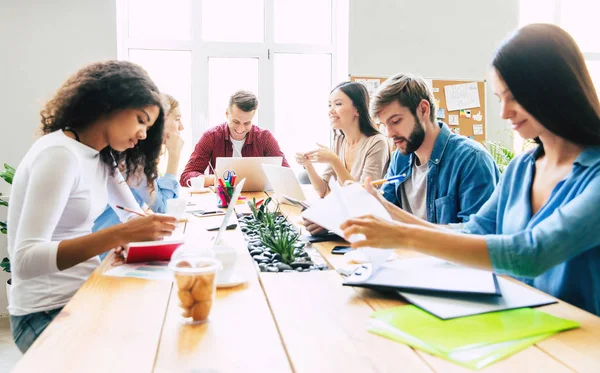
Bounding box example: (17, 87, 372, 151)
(369, 305, 579, 369)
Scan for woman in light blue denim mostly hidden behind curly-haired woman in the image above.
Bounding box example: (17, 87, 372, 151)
(92, 93, 183, 232)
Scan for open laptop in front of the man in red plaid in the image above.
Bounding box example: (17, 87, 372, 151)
(215, 157, 283, 192)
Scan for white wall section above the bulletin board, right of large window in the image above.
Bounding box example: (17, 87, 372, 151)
(349, 0, 519, 145)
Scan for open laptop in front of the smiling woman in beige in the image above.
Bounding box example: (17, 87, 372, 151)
(262, 164, 308, 208)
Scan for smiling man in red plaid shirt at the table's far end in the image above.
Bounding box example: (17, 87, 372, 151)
(179, 91, 290, 186)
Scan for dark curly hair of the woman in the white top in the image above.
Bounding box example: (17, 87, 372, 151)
(40, 61, 164, 190)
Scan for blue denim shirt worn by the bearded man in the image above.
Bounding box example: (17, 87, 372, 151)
(382, 122, 500, 224)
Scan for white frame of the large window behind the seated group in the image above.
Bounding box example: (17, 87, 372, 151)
(117, 0, 349, 145)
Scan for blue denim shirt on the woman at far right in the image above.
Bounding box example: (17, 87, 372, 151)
(464, 147, 600, 316)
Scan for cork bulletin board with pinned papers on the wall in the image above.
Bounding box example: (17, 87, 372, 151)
(350, 76, 486, 143)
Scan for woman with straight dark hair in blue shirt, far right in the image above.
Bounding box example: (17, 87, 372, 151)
(342, 24, 600, 316)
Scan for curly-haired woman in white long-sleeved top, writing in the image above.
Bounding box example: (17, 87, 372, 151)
(7, 61, 176, 352)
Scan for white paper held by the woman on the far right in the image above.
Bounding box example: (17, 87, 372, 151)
(302, 182, 392, 237)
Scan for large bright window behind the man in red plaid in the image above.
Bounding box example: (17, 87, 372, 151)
(117, 0, 349, 173)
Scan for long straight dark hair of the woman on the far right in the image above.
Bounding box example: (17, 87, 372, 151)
(492, 24, 600, 146)
